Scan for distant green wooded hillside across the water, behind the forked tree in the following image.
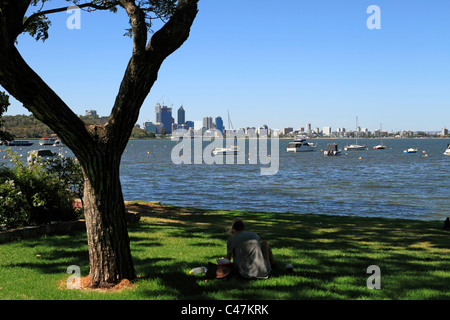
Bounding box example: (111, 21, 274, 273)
(0, 115, 154, 139)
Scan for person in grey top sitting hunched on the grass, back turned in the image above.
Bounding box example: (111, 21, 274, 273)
(227, 219, 273, 279)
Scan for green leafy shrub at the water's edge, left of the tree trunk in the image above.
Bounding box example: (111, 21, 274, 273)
(0, 151, 83, 228)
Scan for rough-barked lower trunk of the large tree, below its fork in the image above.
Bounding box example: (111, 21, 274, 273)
(80, 152, 135, 287)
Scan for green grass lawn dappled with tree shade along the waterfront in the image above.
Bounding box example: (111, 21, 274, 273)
(0, 202, 450, 300)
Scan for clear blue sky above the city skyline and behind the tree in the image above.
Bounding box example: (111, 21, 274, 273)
(3, 0, 450, 131)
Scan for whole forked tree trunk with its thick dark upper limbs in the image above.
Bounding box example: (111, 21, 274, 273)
(0, 0, 198, 287)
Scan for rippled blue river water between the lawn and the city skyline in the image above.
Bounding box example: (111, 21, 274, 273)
(0, 139, 450, 220)
